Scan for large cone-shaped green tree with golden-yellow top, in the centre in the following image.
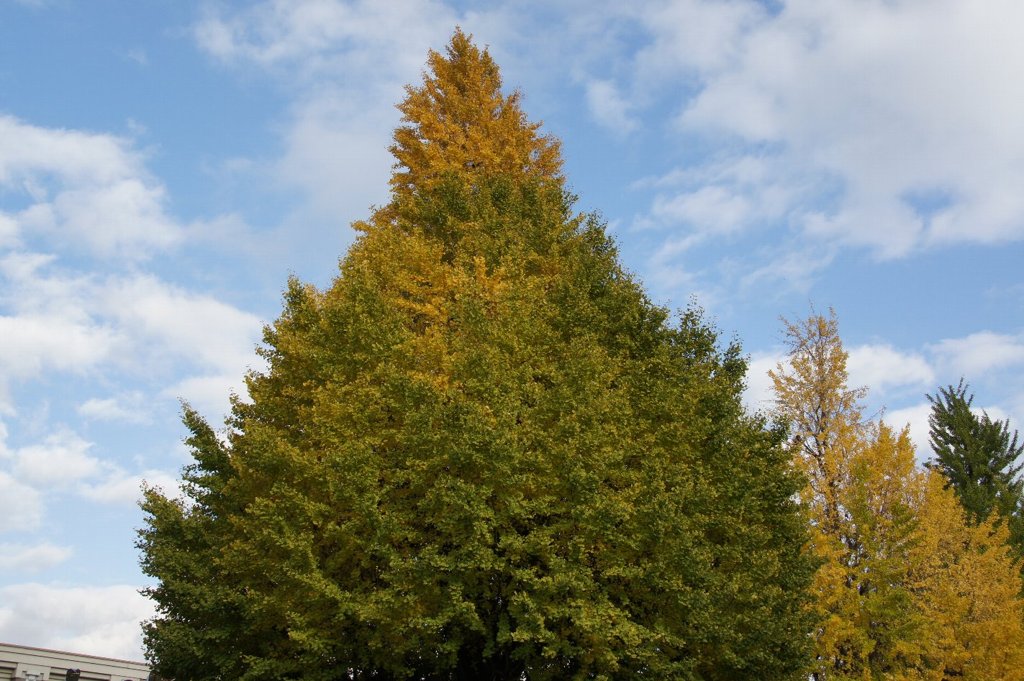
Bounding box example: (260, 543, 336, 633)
(139, 32, 813, 680)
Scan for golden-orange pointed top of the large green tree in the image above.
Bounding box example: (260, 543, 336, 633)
(390, 28, 562, 198)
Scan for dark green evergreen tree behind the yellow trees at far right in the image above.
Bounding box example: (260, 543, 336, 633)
(928, 380, 1024, 557)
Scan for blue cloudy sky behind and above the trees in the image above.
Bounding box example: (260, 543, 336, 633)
(0, 0, 1024, 658)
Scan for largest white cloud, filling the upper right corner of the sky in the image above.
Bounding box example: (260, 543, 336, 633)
(608, 0, 1024, 257)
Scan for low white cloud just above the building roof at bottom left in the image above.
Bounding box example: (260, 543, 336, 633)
(0, 583, 155, 659)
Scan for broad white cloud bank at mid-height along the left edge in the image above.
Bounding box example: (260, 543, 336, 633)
(0, 253, 262, 393)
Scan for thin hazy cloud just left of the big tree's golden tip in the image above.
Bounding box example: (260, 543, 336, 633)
(194, 0, 459, 223)
